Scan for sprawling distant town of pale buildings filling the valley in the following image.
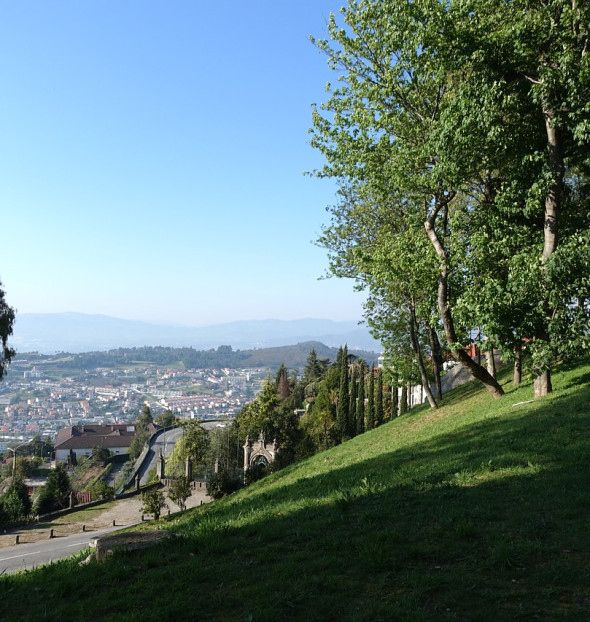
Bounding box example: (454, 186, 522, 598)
(0, 357, 269, 451)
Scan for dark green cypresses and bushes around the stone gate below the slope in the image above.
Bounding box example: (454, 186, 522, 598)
(207, 346, 415, 497)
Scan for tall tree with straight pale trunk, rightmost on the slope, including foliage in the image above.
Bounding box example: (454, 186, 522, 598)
(454, 0, 590, 396)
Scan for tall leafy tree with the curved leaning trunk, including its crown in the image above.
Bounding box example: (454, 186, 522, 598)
(312, 0, 503, 397)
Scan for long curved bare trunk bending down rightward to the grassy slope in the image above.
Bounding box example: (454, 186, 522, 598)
(424, 195, 504, 399)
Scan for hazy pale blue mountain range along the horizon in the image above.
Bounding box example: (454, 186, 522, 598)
(10, 313, 381, 354)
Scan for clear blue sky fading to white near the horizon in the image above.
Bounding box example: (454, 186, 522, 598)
(0, 0, 363, 325)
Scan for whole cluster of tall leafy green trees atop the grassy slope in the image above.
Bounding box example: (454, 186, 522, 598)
(310, 0, 590, 407)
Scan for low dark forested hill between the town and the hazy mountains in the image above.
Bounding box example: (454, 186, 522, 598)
(15, 341, 378, 370)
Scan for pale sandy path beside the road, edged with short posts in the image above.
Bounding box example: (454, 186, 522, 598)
(0, 484, 211, 548)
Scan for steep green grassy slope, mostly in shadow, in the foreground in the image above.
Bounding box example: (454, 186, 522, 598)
(0, 363, 590, 621)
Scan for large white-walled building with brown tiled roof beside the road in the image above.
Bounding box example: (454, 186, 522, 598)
(55, 424, 142, 464)
